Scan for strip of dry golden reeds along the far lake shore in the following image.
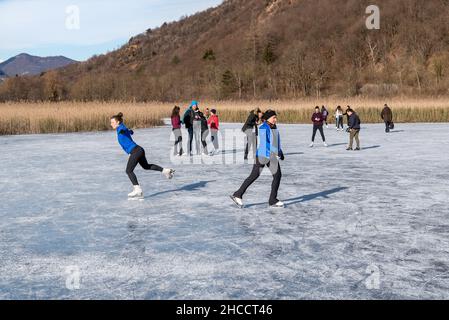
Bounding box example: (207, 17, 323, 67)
(0, 99, 449, 135)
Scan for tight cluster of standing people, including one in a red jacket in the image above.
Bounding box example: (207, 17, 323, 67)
(171, 101, 220, 156)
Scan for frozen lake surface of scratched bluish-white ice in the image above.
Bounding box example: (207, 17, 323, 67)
(0, 124, 449, 299)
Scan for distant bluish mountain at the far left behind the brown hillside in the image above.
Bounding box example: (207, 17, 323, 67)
(0, 53, 77, 77)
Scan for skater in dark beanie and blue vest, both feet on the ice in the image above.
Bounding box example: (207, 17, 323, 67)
(231, 110, 285, 208)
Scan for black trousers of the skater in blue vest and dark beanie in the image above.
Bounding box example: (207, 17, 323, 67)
(234, 158, 282, 206)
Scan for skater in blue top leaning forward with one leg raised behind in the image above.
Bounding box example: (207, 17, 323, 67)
(111, 113, 175, 199)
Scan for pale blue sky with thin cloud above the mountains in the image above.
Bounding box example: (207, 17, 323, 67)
(0, 0, 222, 61)
